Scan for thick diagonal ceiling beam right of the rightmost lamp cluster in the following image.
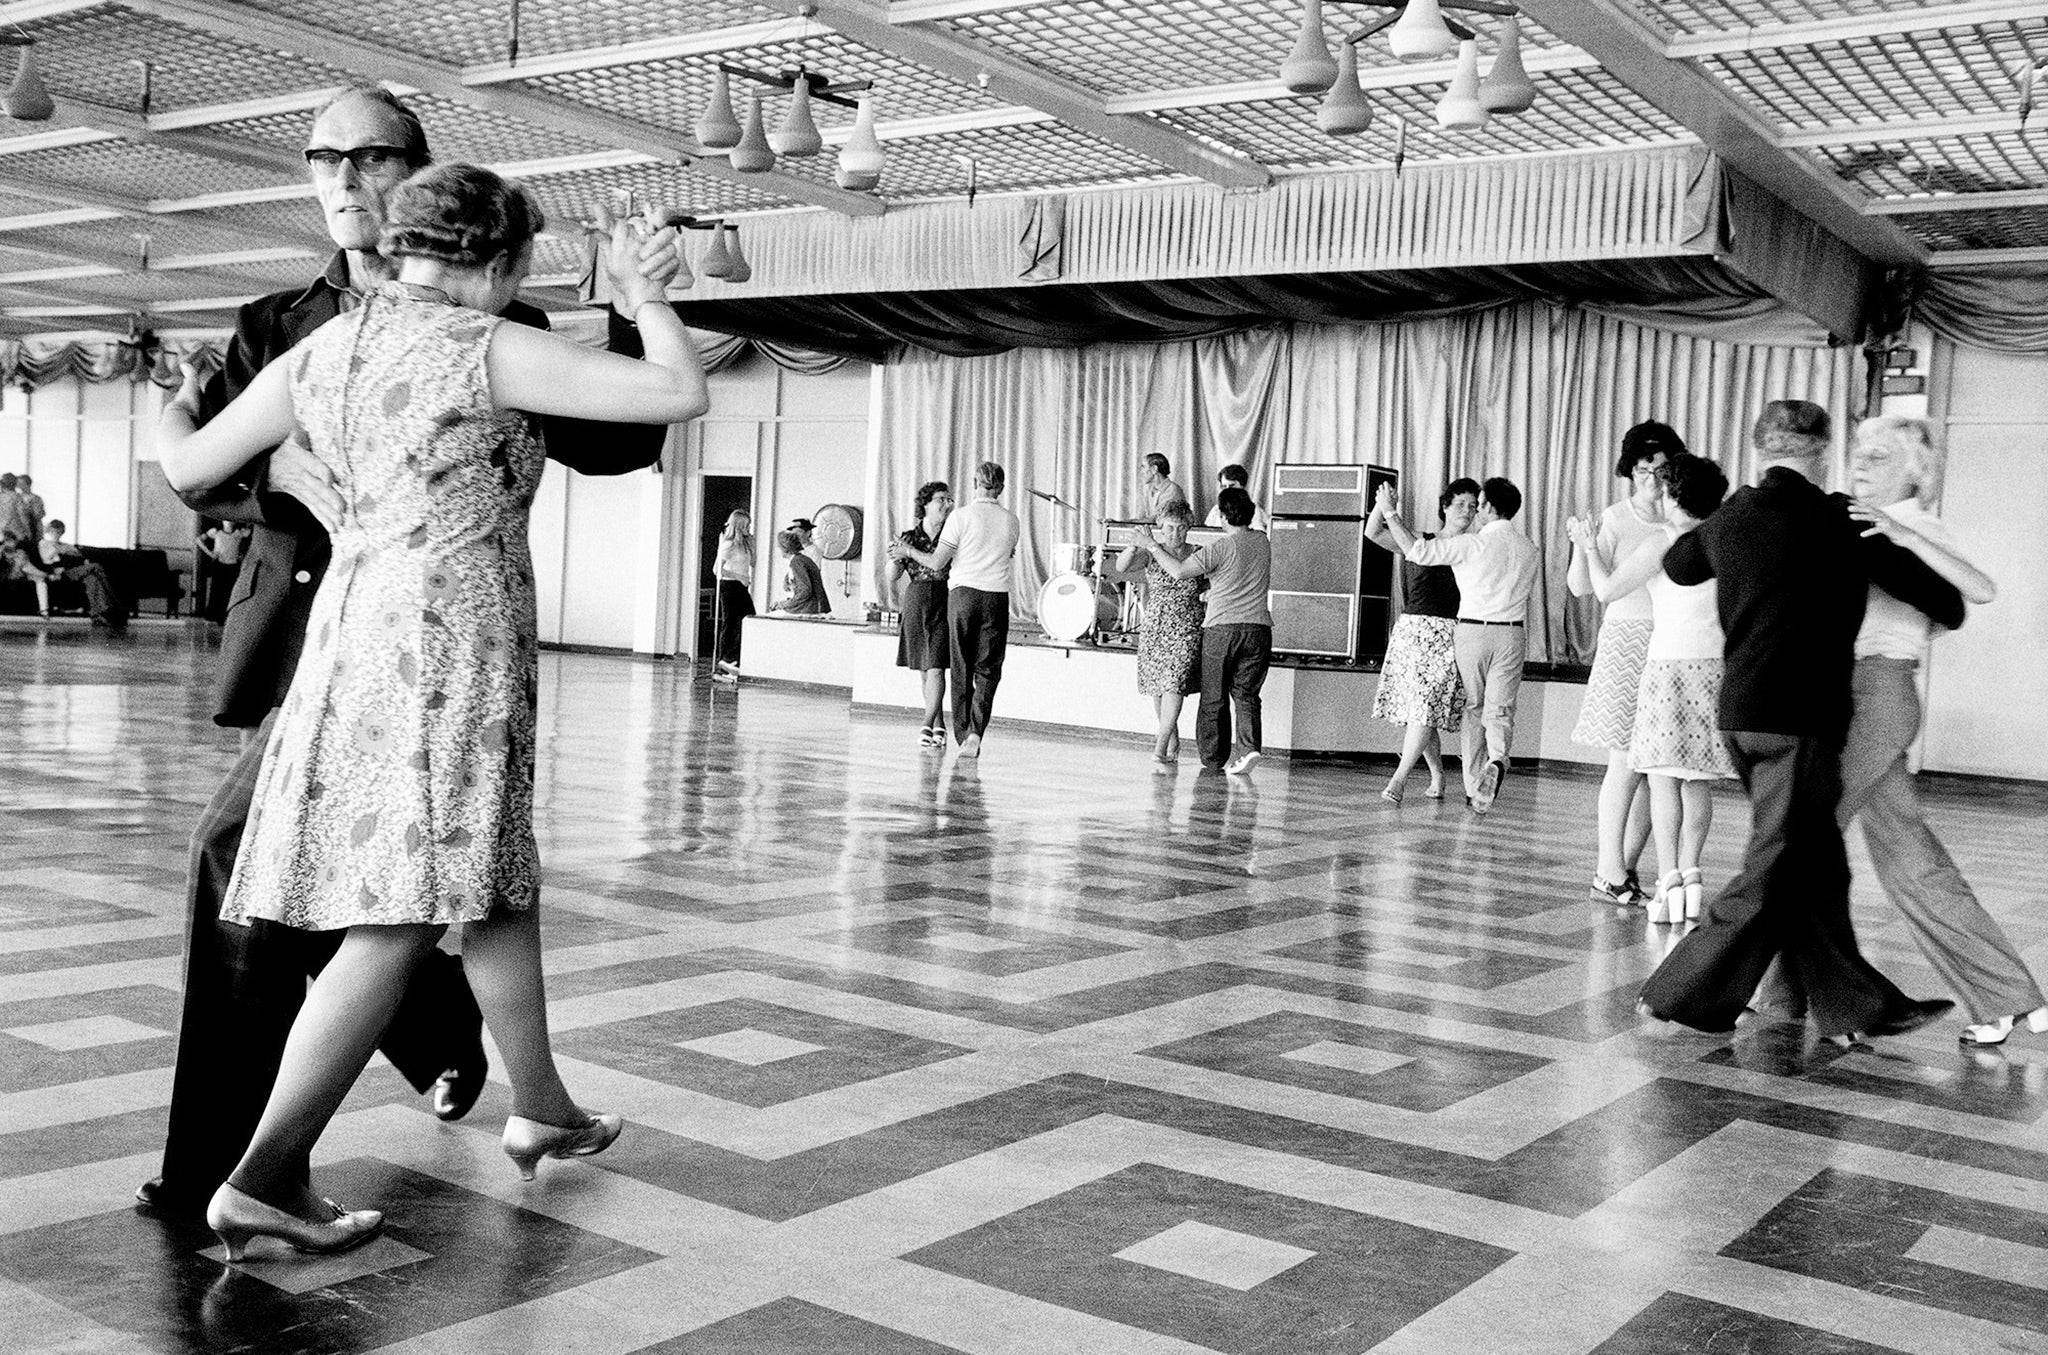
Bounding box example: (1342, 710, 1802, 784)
(1522, 0, 1927, 264)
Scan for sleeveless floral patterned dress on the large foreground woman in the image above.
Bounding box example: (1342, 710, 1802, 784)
(221, 285, 545, 929)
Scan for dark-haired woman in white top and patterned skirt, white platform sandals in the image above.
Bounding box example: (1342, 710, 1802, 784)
(1575, 452, 1735, 923)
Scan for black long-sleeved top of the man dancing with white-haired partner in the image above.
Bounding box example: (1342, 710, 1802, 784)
(1665, 467, 1964, 743)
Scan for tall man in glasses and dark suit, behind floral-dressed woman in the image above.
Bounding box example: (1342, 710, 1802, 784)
(137, 86, 676, 1214)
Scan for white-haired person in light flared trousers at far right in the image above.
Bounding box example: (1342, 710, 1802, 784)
(1839, 416, 2048, 1044)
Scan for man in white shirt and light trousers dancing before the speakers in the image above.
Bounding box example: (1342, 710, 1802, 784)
(1380, 475, 1536, 815)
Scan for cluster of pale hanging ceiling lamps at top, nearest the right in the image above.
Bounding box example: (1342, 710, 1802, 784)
(1280, 0, 1536, 137)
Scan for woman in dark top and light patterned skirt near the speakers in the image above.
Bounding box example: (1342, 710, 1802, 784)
(1366, 479, 1479, 804)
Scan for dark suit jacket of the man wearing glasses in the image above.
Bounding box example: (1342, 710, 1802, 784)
(180, 254, 668, 729)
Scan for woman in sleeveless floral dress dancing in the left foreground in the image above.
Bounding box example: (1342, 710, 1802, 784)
(160, 166, 707, 1259)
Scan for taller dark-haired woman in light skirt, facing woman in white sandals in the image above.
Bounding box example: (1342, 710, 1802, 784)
(1565, 420, 1686, 905)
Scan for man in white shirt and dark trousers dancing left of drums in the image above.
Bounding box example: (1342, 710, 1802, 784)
(889, 461, 1024, 757)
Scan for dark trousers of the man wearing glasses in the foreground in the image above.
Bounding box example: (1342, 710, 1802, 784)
(162, 712, 483, 1212)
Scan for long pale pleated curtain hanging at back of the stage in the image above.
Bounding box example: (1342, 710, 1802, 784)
(864, 303, 1855, 663)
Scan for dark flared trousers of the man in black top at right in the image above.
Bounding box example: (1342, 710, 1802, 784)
(1642, 733, 1907, 1036)
